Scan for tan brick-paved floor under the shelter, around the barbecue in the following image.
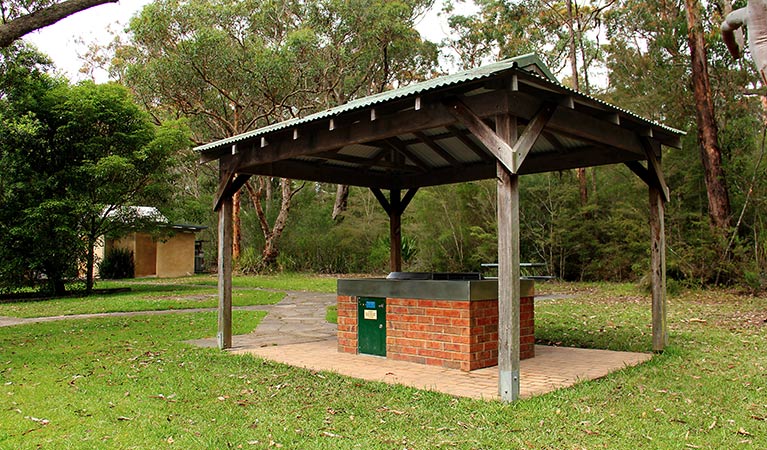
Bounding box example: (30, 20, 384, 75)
(233, 339, 652, 399)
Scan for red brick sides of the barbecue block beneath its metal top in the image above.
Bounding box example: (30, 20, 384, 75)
(338, 296, 535, 371)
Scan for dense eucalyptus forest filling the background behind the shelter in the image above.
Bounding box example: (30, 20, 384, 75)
(0, 0, 767, 290)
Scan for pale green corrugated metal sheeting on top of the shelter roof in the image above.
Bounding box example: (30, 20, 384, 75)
(195, 53, 685, 152)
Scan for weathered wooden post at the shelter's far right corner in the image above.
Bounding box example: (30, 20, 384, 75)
(650, 184, 668, 352)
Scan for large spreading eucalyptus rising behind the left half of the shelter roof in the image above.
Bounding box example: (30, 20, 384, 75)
(113, 0, 437, 264)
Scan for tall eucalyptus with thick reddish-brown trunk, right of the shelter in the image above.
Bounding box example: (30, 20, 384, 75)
(608, 0, 751, 235)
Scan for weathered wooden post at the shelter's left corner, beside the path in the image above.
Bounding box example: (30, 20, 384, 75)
(217, 197, 232, 350)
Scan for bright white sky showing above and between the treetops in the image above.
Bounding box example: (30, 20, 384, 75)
(24, 0, 471, 82)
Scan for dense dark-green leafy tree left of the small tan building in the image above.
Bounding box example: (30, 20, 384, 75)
(0, 47, 188, 293)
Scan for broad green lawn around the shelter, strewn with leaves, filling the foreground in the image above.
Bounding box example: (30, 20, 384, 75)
(0, 276, 767, 449)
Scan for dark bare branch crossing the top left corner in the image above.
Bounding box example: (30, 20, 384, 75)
(0, 0, 117, 48)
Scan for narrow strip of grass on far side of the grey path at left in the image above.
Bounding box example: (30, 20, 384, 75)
(0, 282, 284, 317)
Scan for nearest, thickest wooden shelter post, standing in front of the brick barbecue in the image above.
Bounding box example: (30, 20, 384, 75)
(496, 115, 520, 402)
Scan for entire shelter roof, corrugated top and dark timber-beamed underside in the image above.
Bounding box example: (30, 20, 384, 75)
(196, 54, 684, 193)
